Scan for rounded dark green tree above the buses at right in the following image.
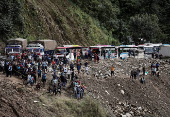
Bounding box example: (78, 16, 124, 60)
(129, 14, 161, 43)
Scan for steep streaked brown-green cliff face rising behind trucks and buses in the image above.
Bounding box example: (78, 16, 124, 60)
(5, 0, 116, 46)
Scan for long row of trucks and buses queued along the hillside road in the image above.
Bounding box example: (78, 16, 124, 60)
(5, 38, 170, 60)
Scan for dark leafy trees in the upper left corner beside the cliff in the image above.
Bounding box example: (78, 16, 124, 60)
(0, 0, 22, 41)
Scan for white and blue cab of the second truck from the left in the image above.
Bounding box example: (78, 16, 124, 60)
(26, 43, 44, 55)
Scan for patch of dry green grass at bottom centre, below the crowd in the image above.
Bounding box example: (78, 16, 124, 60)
(38, 96, 107, 117)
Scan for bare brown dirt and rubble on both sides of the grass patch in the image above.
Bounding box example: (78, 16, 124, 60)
(0, 58, 170, 117)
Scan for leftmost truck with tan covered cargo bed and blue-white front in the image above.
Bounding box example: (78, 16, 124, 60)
(5, 38, 27, 54)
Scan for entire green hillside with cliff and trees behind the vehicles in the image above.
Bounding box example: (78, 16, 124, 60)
(0, 0, 170, 45)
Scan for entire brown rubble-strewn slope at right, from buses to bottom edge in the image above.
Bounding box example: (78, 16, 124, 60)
(82, 58, 170, 117)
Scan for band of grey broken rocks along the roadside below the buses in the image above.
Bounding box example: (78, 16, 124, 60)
(91, 58, 170, 79)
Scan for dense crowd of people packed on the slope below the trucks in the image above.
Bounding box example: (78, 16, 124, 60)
(0, 51, 91, 100)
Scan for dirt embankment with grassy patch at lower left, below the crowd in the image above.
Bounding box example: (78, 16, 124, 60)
(0, 70, 106, 117)
